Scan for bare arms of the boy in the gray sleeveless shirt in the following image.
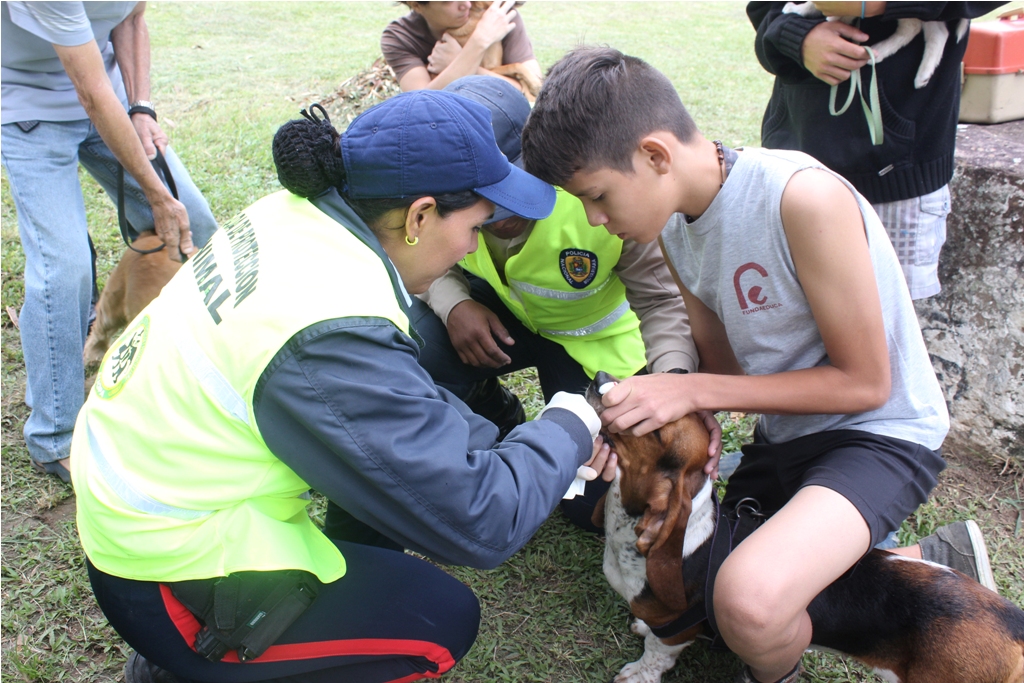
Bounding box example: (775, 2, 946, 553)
(602, 170, 890, 434)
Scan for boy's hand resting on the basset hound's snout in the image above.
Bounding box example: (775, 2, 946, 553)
(601, 373, 696, 436)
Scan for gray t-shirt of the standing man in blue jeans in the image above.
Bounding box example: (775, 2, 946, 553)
(0, 1, 138, 124)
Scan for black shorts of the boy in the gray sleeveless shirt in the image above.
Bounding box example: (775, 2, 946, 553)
(722, 429, 946, 548)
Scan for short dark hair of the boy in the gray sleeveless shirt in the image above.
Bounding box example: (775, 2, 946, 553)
(522, 46, 697, 185)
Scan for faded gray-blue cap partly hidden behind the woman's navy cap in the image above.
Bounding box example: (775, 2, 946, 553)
(444, 76, 532, 223)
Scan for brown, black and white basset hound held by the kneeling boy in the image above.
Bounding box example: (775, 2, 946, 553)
(587, 373, 1024, 683)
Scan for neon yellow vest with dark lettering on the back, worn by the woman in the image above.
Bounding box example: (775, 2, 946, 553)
(72, 191, 409, 583)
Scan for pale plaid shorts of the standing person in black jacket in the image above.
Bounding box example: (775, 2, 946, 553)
(871, 185, 949, 299)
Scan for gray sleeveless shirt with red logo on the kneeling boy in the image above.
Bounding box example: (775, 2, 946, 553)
(662, 148, 949, 451)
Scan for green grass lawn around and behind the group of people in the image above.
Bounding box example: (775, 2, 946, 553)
(0, 2, 1024, 683)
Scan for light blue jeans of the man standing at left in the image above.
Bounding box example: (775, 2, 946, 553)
(0, 119, 217, 463)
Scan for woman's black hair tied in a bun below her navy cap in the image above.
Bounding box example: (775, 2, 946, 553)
(272, 104, 480, 230)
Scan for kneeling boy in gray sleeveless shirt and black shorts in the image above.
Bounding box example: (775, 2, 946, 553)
(522, 47, 991, 683)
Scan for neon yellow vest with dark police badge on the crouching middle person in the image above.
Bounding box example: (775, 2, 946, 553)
(462, 188, 646, 377)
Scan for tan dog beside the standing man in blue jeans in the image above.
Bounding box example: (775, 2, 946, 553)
(82, 230, 181, 365)
